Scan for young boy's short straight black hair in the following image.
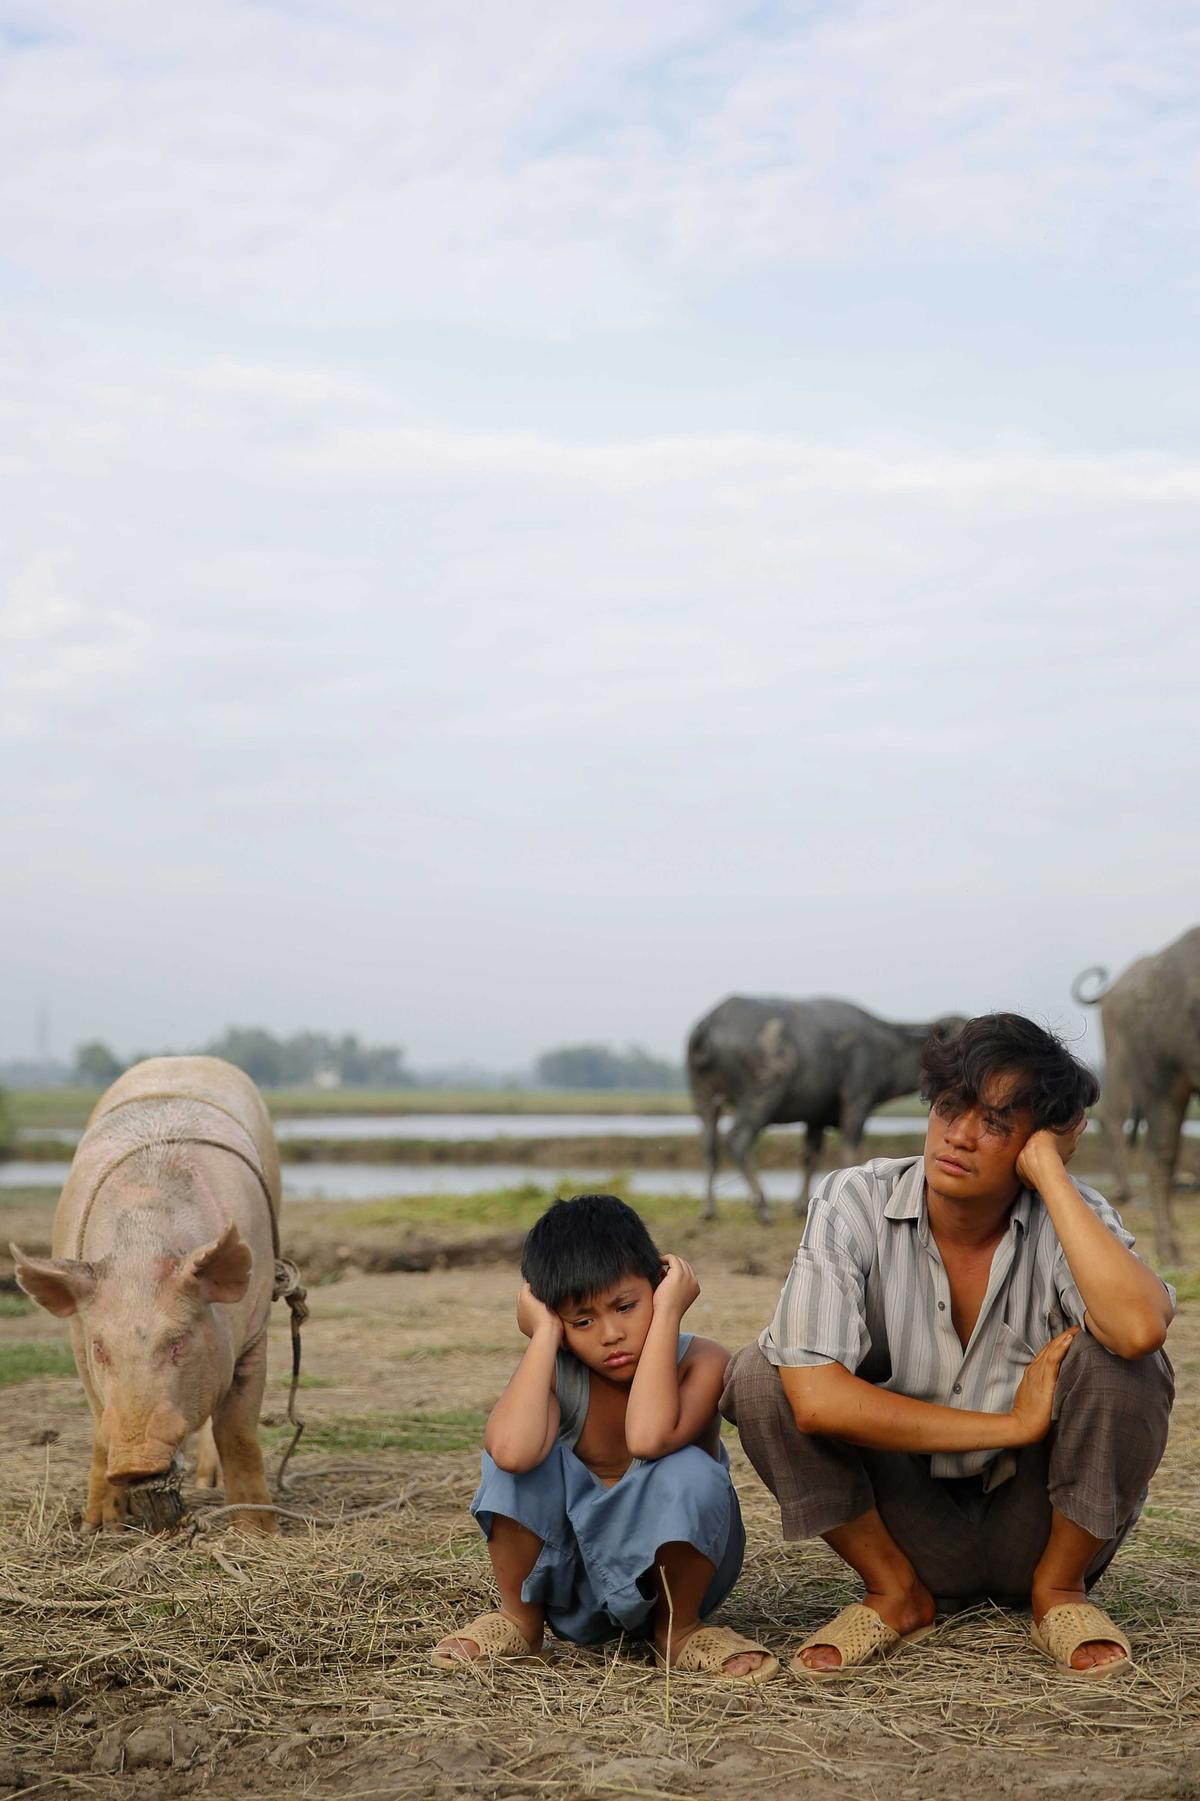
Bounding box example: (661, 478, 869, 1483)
(521, 1194, 661, 1311)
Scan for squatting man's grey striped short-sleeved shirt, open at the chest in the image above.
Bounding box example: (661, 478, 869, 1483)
(759, 1156, 1175, 1489)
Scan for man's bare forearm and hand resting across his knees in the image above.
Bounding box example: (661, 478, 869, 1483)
(778, 1326, 1079, 1452)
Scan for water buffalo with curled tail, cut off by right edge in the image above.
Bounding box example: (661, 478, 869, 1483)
(1070, 926, 1200, 1264)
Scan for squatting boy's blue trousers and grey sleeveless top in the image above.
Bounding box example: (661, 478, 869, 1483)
(470, 1333, 746, 1644)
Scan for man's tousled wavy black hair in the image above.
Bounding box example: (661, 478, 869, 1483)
(921, 1014, 1099, 1131)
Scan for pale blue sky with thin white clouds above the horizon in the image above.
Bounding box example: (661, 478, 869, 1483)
(0, 0, 1200, 1066)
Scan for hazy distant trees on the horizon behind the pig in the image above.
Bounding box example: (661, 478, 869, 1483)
(76, 1027, 413, 1088)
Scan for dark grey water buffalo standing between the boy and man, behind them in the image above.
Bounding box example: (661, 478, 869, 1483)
(686, 994, 966, 1219)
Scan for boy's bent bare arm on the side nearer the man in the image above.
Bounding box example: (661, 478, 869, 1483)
(625, 1257, 728, 1459)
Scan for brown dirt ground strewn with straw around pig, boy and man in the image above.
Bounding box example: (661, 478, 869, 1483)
(0, 1196, 1200, 1801)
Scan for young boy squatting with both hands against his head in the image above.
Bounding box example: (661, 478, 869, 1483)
(432, 1194, 778, 1682)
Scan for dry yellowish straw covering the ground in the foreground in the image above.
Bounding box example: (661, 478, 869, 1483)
(0, 1432, 1200, 1801)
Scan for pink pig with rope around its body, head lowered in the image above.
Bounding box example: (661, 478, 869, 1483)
(13, 1057, 279, 1533)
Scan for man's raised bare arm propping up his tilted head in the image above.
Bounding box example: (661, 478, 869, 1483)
(1016, 1122, 1173, 1358)
